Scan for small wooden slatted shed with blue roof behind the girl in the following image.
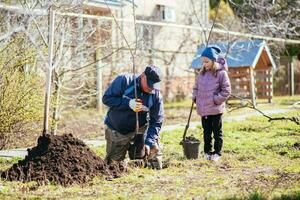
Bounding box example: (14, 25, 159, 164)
(191, 40, 276, 105)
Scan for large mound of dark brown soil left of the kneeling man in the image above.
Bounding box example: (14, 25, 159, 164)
(1, 134, 126, 186)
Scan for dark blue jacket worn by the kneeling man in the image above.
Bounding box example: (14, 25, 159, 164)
(102, 74, 164, 148)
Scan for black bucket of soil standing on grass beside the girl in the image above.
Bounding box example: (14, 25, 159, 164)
(182, 137, 200, 159)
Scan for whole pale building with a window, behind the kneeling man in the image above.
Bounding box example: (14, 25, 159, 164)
(85, 0, 209, 100)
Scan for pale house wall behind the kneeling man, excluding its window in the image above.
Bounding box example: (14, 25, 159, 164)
(110, 0, 209, 100)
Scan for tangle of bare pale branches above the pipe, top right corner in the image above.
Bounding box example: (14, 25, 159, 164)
(230, 0, 300, 39)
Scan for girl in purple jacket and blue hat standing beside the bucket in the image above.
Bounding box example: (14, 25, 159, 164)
(193, 46, 231, 161)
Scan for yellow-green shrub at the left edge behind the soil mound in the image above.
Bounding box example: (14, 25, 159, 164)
(0, 35, 43, 149)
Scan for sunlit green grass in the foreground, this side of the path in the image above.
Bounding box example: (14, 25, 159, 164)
(0, 110, 300, 200)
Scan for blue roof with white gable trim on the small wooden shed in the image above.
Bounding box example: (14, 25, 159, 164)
(190, 40, 276, 69)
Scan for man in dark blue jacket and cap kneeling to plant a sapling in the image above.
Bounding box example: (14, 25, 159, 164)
(102, 65, 164, 169)
